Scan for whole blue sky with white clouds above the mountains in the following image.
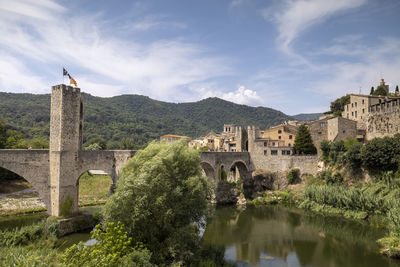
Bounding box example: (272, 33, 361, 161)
(0, 0, 400, 115)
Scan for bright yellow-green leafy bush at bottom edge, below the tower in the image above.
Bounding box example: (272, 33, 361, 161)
(61, 222, 153, 267)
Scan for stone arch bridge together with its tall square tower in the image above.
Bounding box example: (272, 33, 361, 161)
(0, 84, 253, 216)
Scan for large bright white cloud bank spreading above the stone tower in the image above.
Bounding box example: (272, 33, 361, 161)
(0, 0, 230, 100)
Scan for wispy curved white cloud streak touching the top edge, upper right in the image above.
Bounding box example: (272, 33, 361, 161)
(263, 0, 366, 55)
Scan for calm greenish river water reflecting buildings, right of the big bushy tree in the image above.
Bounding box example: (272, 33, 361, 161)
(204, 207, 400, 267)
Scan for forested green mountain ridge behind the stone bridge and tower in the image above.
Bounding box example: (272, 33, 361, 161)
(0, 92, 292, 149)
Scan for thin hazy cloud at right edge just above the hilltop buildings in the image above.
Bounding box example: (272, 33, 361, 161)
(312, 38, 400, 98)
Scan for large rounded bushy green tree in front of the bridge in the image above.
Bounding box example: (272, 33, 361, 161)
(103, 140, 208, 265)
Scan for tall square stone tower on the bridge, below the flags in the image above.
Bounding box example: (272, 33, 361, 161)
(49, 84, 83, 216)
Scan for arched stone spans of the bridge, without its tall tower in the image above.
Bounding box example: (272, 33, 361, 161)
(0, 149, 251, 216)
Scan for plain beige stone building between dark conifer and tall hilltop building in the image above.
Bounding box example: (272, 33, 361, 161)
(306, 117, 357, 149)
